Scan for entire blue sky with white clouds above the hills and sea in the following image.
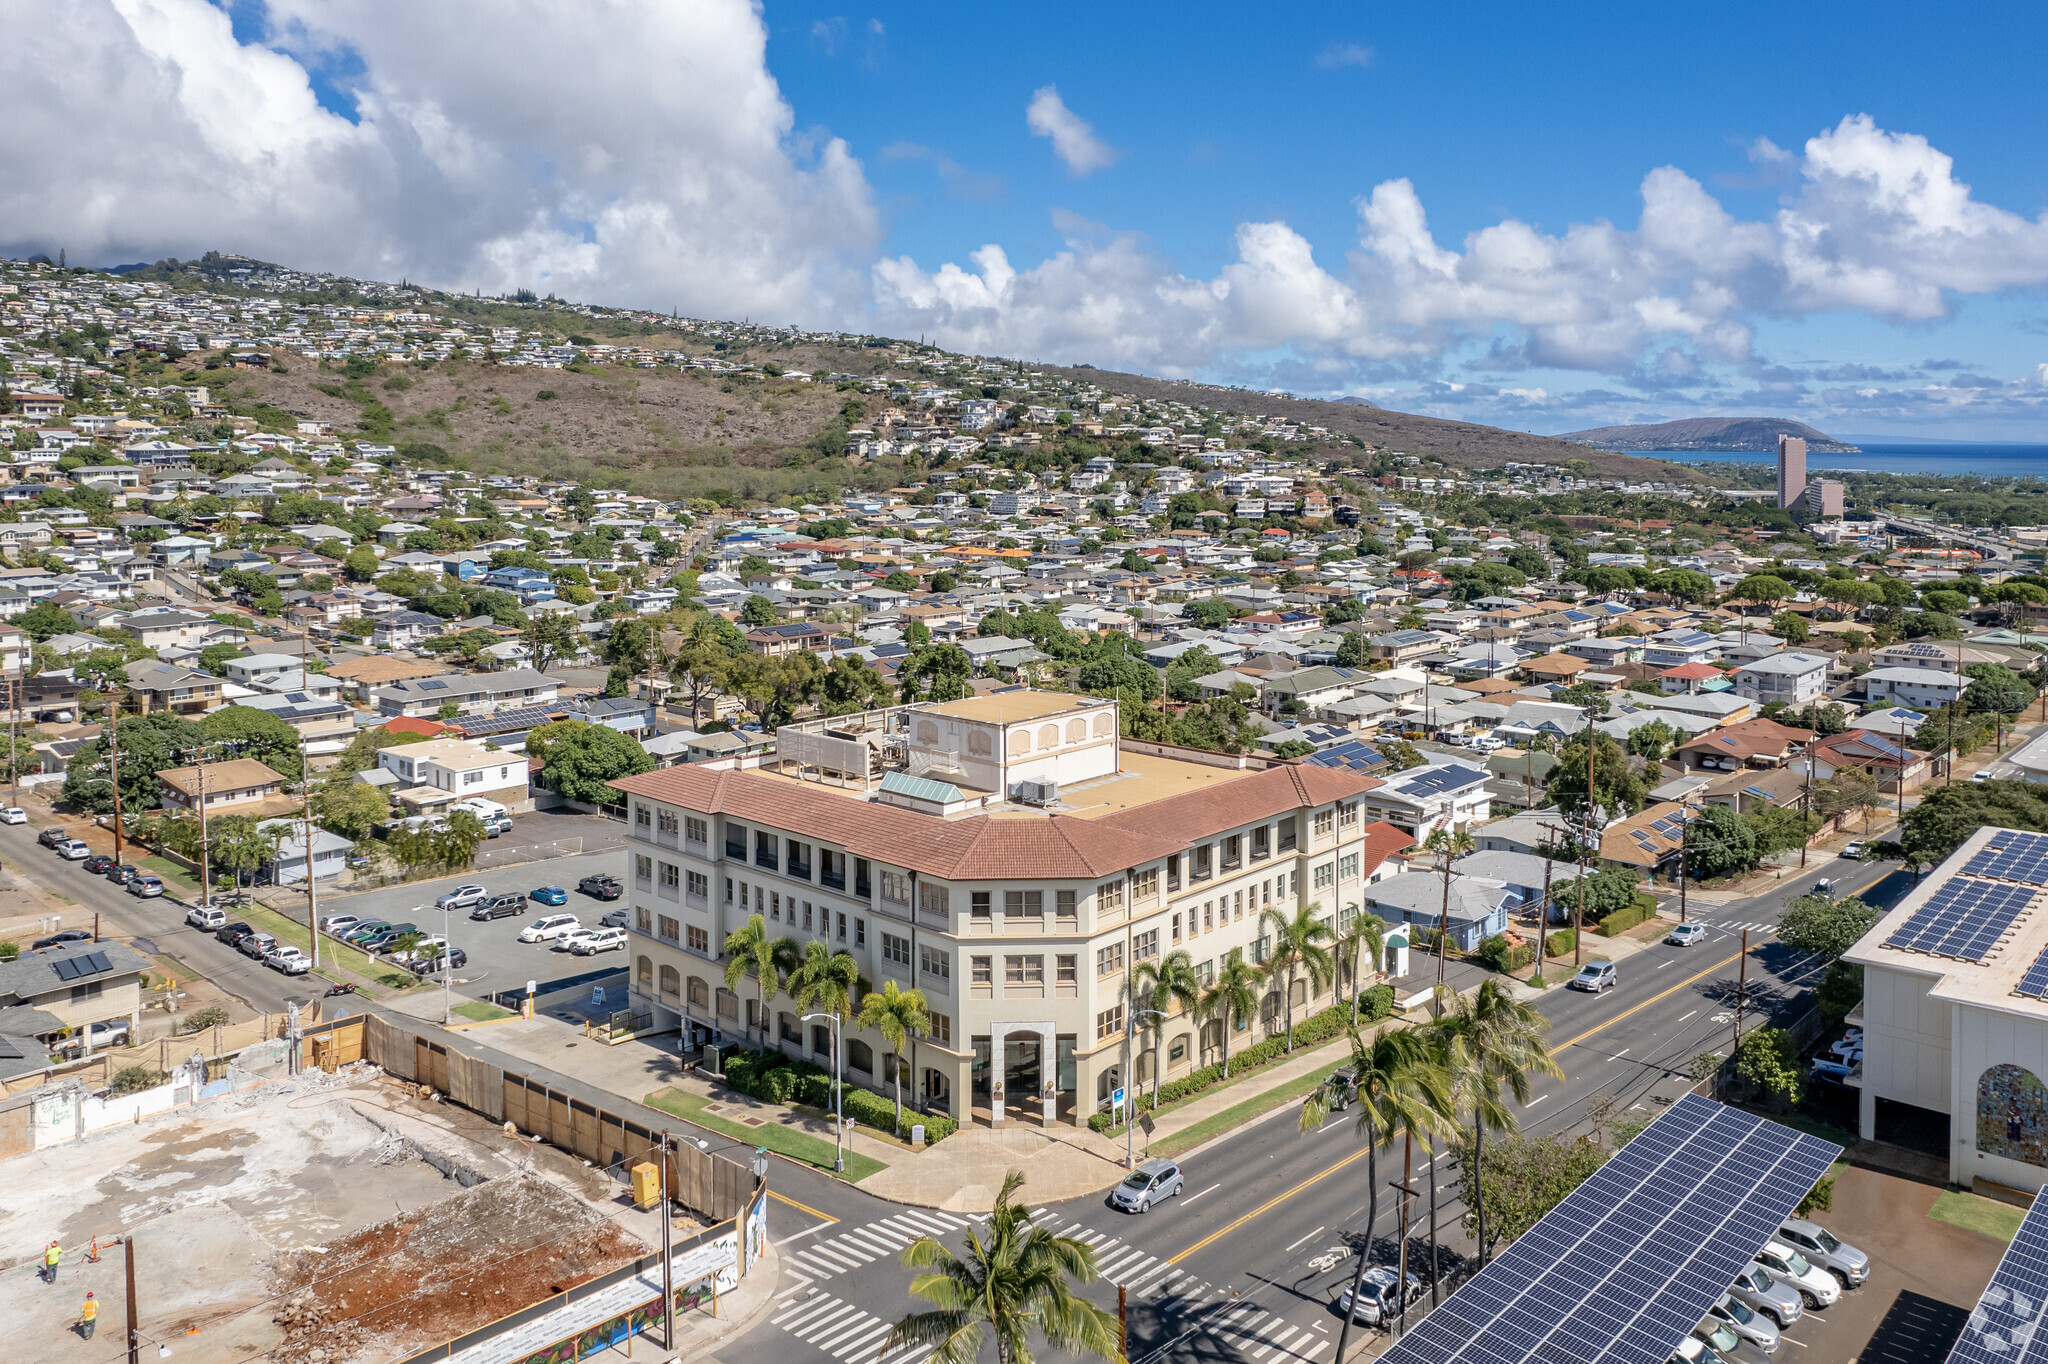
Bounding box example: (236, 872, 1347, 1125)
(12, 0, 2048, 442)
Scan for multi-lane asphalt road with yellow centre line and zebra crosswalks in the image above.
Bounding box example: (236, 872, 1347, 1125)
(719, 858, 1911, 1364)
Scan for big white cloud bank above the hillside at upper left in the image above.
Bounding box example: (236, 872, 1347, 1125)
(0, 0, 881, 319)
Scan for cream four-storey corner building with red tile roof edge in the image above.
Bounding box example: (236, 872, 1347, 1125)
(606, 688, 1380, 1124)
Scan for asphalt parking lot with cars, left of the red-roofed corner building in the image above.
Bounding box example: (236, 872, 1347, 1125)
(319, 851, 627, 997)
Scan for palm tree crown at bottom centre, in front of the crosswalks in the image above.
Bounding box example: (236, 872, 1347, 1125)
(883, 1169, 1124, 1364)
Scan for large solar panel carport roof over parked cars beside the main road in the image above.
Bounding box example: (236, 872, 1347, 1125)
(1380, 1094, 1841, 1364)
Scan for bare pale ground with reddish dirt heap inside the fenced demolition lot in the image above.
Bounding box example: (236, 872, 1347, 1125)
(0, 1067, 653, 1364)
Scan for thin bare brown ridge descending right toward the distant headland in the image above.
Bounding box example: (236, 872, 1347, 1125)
(1032, 365, 1696, 481)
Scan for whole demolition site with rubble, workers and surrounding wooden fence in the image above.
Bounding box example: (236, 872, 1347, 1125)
(0, 1018, 758, 1364)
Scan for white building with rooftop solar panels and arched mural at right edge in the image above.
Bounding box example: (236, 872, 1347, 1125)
(1843, 829, 2048, 1190)
